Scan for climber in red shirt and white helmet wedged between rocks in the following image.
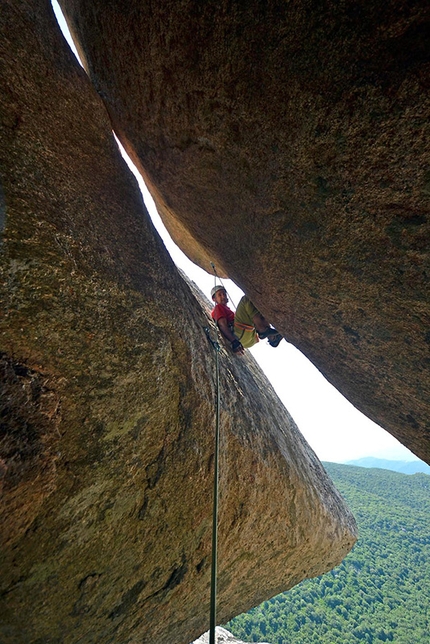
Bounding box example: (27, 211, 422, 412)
(211, 284, 282, 355)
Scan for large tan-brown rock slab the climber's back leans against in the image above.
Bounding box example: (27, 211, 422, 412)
(0, 0, 356, 644)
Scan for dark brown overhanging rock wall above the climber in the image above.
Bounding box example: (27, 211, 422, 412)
(60, 0, 430, 462)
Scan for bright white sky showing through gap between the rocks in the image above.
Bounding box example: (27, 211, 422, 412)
(52, 0, 417, 463)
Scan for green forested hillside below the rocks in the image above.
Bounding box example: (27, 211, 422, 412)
(226, 463, 430, 644)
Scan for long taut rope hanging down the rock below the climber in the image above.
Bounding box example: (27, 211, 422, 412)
(204, 327, 220, 644)
